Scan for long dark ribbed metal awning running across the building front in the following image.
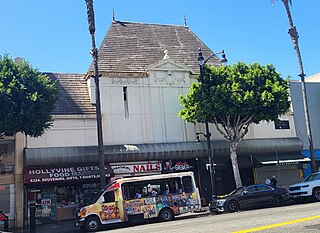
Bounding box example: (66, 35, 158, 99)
(24, 138, 303, 166)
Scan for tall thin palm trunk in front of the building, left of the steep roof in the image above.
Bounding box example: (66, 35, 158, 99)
(85, 0, 106, 188)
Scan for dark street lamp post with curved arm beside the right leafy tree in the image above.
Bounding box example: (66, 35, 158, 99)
(196, 48, 228, 196)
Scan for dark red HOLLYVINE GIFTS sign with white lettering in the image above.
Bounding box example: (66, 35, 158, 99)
(23, 164, 112, 184)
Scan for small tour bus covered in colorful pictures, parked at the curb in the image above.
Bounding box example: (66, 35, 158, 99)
(75, 172, 201, 231)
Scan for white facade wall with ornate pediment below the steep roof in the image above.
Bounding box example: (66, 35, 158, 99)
(27, 59, 296, 148)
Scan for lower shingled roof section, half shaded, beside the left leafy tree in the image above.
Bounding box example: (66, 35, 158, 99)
(44, 73, 96, 115)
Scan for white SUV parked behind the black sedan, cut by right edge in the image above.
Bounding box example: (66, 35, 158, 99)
(289, 172, 320, 201)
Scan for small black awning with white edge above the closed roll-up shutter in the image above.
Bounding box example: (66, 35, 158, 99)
(253, 153, 311, 165)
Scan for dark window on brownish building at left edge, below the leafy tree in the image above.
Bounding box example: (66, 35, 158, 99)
(0, 141, 14, 175)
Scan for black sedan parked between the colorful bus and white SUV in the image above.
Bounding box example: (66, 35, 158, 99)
(209, 184, 289, 213)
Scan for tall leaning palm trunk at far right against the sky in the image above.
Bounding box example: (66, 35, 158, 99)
(272, 0, 317, 172)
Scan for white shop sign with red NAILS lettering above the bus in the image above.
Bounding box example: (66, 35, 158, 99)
(111, 163, 162, 174)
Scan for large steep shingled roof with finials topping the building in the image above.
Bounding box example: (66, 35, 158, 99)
(89, 21, 221, 73)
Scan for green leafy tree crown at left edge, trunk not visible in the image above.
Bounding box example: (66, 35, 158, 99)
(0, 55, 57, 137)
